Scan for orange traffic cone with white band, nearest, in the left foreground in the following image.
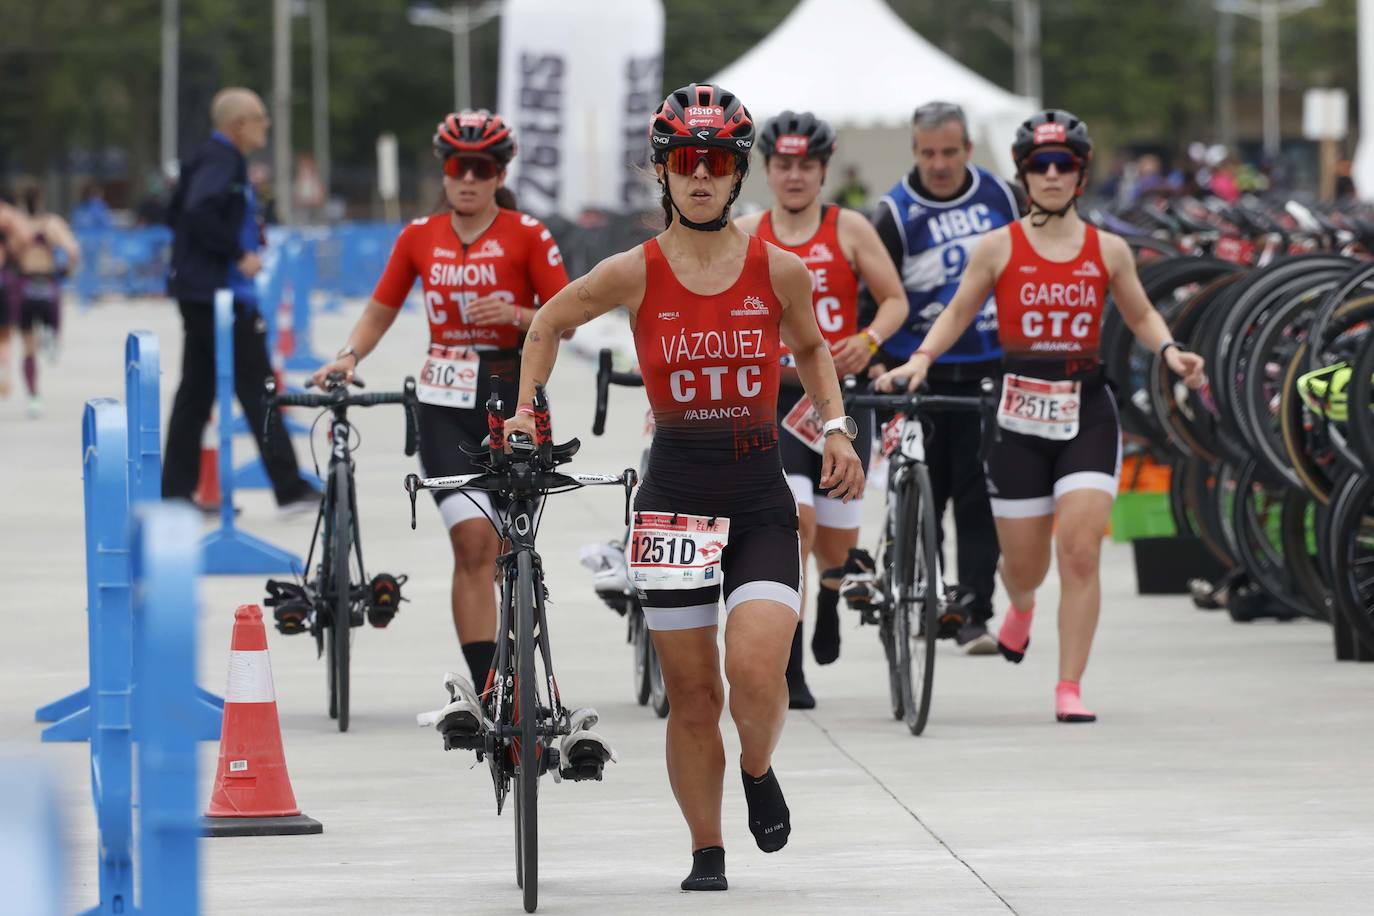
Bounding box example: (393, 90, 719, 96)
(201, 604, 324, 836)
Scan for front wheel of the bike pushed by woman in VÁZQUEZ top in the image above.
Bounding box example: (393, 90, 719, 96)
(515, 551, 541, 913)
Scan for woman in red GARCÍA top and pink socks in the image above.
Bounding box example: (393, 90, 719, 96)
(878, 108, 1204, 722)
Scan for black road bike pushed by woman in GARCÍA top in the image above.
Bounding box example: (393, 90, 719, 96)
(845, 379, 998, 735)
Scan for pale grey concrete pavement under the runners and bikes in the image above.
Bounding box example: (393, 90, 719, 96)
(0, 302, 1374, 916)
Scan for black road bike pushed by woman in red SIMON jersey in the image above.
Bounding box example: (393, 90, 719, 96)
(265, 374, 419, 732)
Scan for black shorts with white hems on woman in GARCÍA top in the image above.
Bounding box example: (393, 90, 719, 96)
(985, 383, 1121, 518)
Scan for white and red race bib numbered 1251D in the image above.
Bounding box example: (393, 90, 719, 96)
(629, 512, 730, 592)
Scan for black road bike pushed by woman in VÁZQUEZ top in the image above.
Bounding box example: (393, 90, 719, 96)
(405, 379, 638, 913)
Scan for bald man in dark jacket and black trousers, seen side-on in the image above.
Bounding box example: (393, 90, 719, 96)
(162, 89, 320, 509)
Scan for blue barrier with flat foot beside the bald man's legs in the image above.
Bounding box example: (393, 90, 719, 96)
(201, 290, 301, 575)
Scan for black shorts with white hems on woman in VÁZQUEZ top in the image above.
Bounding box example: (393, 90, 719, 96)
(635, 428, 801, 630)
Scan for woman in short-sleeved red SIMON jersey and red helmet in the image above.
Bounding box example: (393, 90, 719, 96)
(315, 110, 567, 691)
